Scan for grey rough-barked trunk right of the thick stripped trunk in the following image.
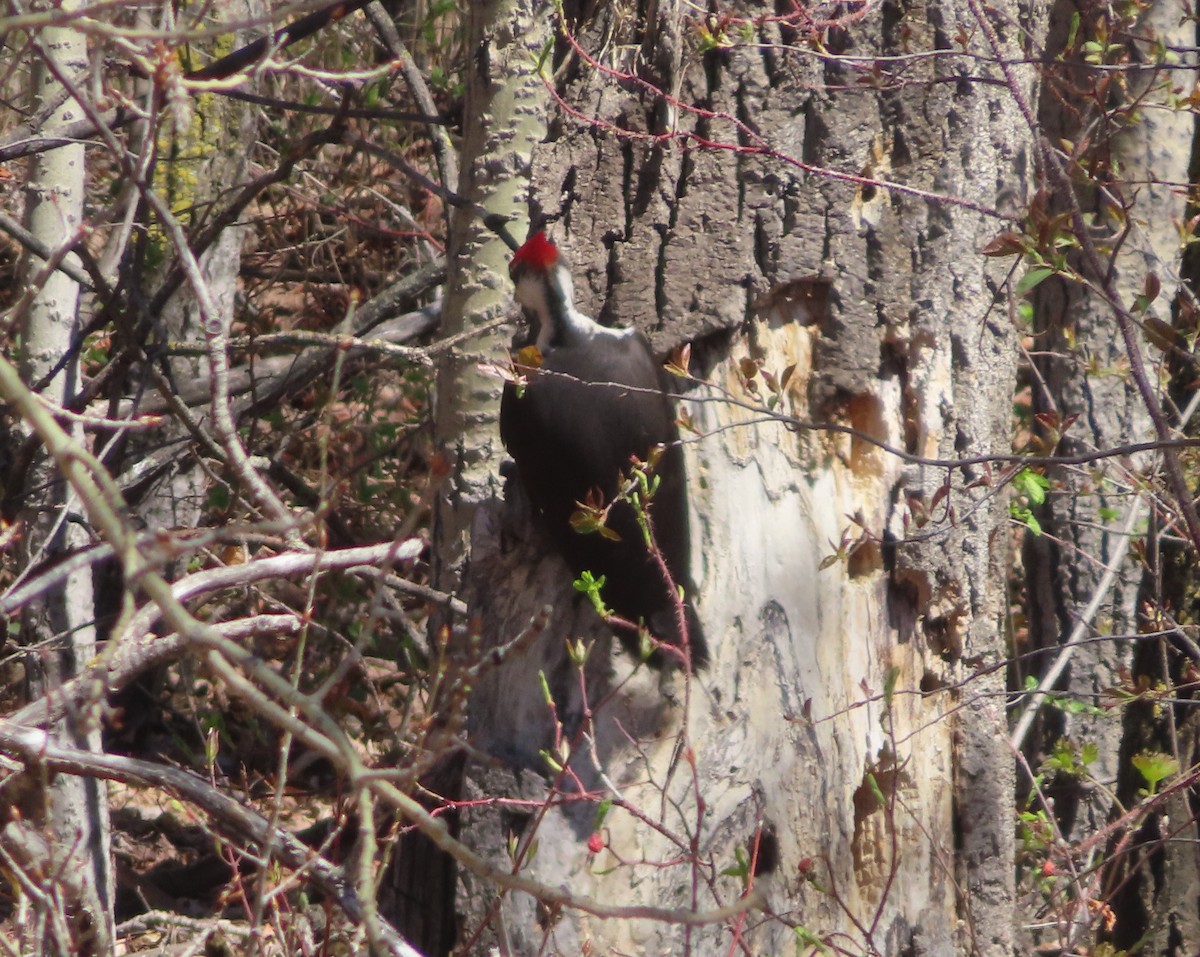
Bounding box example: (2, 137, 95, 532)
(1025, 2, 1192, 836)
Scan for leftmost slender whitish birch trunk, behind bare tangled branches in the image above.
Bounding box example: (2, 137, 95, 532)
(0, 4, 114, 955)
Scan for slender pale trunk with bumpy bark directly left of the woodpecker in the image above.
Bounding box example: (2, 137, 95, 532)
(380, 0, 548, 955)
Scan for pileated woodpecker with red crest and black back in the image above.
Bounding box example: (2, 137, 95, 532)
(500, 233, 708, 668)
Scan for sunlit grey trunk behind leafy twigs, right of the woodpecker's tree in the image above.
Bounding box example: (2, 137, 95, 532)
(1018, 2, 1193, 835)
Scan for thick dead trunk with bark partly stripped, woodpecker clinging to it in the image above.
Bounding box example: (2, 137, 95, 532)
(453, 4, 1031, 955)
